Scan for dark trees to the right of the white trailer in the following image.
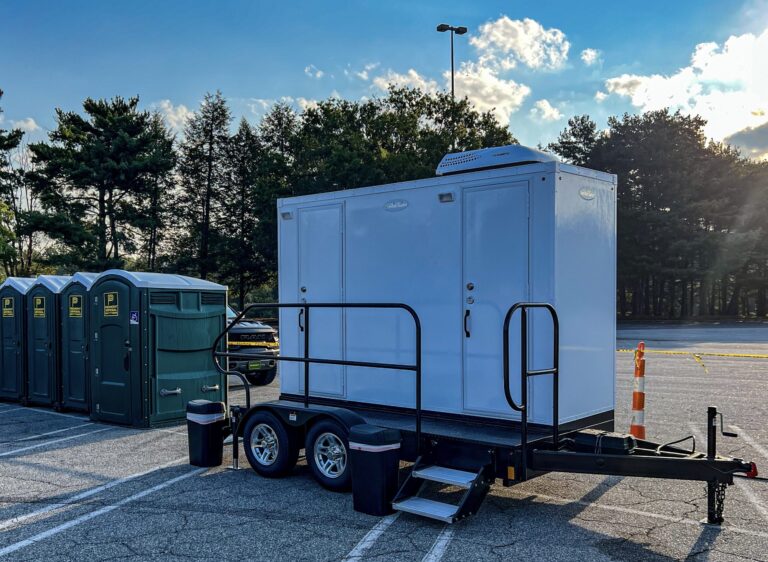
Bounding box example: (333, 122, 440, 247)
(549, 110, 768, 317)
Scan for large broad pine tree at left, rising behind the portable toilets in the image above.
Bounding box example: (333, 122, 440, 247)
(28, 97, 174, 270)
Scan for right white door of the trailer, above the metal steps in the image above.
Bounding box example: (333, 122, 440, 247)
(461, 181, 528, 417)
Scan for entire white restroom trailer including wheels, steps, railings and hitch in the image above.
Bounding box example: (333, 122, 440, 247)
(218, 146, 757, 523)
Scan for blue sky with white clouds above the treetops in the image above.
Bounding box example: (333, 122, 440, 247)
(0, 0, 768, 159)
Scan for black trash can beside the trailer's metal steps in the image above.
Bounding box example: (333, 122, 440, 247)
(349, 424, 402, 515)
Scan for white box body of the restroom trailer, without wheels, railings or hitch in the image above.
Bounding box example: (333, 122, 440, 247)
(278, 147, 616, 425)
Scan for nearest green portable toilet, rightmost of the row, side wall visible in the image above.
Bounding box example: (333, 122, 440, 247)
(89, 269, 227, 427)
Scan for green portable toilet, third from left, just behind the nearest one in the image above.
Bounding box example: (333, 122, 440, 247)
(59, 273, 98, 412)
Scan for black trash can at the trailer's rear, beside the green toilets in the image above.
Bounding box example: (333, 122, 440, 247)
(187, 400, 227, 466)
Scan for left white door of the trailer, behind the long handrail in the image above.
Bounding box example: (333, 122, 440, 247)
(297, 204, 345, 396)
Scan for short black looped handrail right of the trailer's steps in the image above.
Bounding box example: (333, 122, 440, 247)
(502, 302, 560, 480)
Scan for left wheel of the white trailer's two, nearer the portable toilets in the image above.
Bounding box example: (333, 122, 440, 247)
(243, 412, 300, 478)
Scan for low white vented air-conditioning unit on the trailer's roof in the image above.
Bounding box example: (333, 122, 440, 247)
(435, 144, 558, 176)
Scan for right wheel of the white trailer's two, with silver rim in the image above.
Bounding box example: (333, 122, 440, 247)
(305, 419, 352, 492)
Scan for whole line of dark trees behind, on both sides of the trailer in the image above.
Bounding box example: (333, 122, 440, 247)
(0, 88, 768, 319)
